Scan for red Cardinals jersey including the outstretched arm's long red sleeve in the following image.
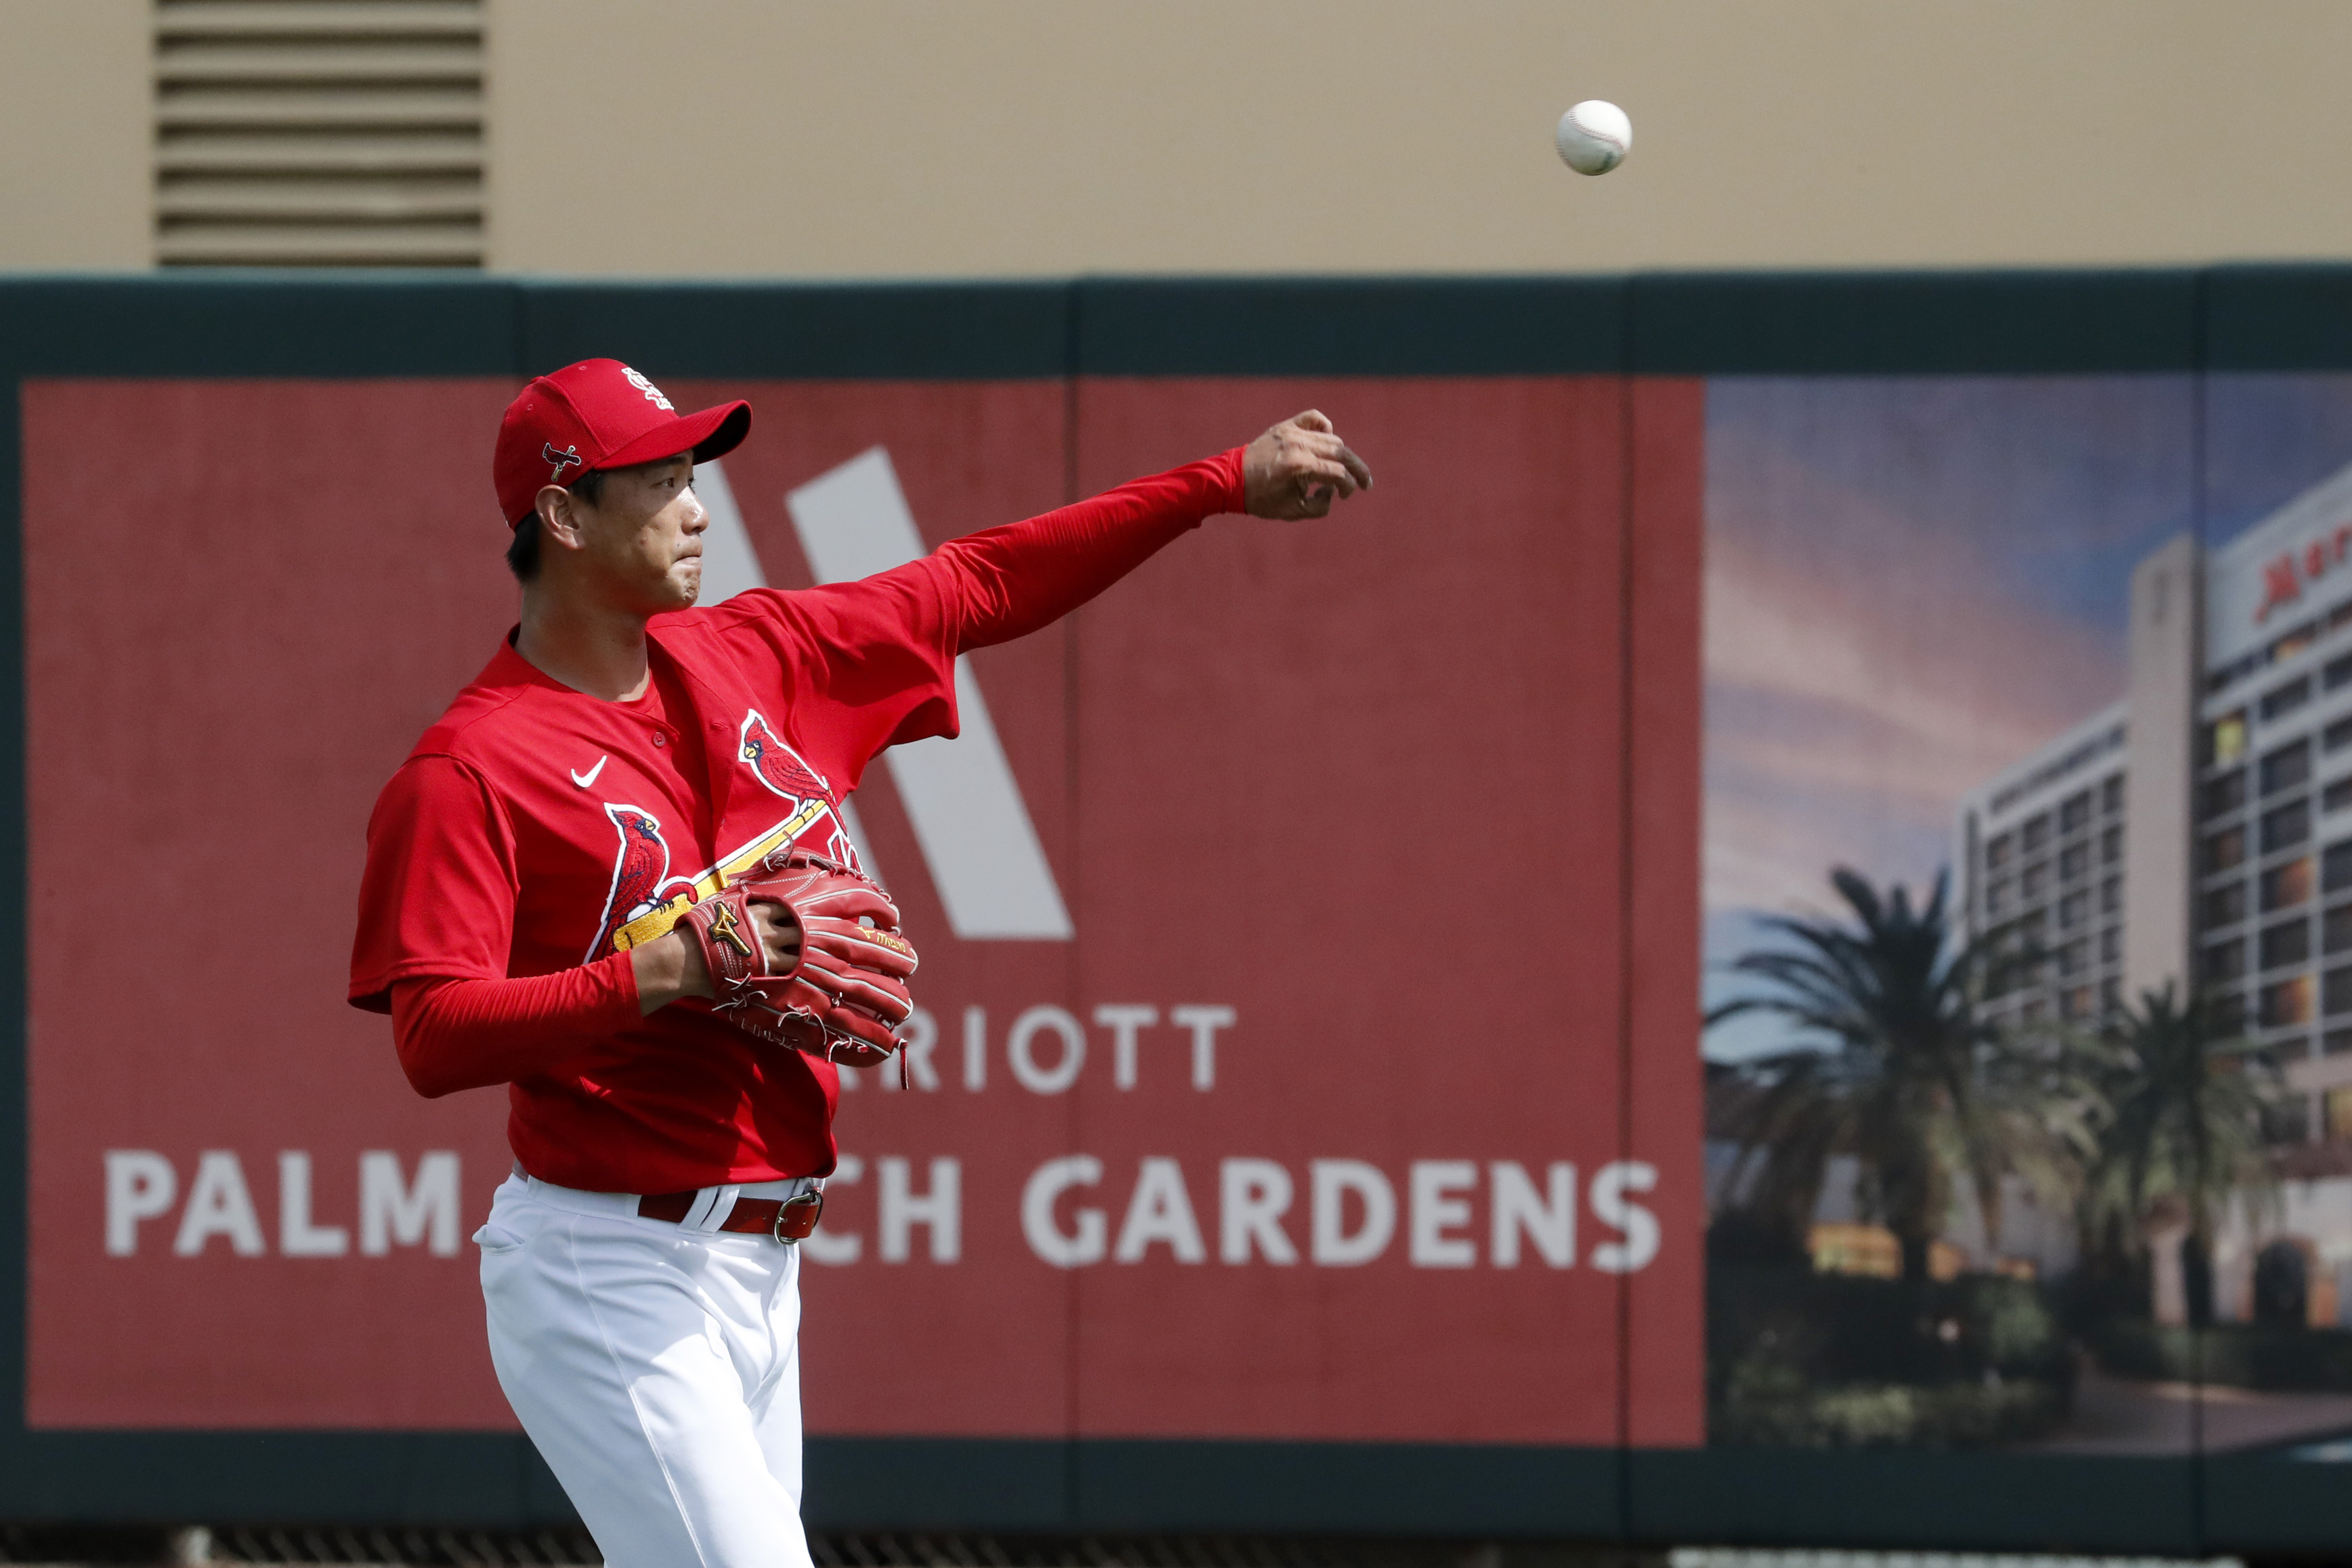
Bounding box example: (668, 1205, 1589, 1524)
(351, 449, 1242, 1192)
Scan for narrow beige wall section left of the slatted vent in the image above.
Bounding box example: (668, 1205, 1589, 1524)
(0, 0, 155, 270)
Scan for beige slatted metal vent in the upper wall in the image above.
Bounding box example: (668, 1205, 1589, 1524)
(155, 0, 482, 266)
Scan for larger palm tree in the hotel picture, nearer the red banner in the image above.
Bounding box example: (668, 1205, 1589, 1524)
(1707, 867, 2098, 1281)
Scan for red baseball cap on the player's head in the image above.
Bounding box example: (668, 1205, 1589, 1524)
(489, 359, 750, 527)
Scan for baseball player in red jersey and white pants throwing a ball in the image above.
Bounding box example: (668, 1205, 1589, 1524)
(351, 359, 1371, 1568)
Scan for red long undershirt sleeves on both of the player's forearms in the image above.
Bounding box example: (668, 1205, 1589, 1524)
(393, 449, 1242, 1096)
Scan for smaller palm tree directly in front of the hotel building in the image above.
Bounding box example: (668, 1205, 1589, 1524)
(2079, 982, 2276, 1316)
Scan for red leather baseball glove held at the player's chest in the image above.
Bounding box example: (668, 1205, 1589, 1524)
(678, 851, 915, 1067)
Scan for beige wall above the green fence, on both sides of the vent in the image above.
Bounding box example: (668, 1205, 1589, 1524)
(14, 0, 2352, 277)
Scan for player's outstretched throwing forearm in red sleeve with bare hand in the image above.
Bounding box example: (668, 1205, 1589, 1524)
(929, 409, 1371, 653)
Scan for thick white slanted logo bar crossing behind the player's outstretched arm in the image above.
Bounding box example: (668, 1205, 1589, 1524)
(783, 447, 1070, 943)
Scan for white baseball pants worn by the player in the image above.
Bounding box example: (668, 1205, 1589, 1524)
(472, 1173, 812, 1568)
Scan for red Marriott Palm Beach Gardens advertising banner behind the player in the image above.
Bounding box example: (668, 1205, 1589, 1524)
(24, 376, 1705, 1446)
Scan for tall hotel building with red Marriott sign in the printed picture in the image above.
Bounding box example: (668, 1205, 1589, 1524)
(1954, 465, 2352, 1317)
